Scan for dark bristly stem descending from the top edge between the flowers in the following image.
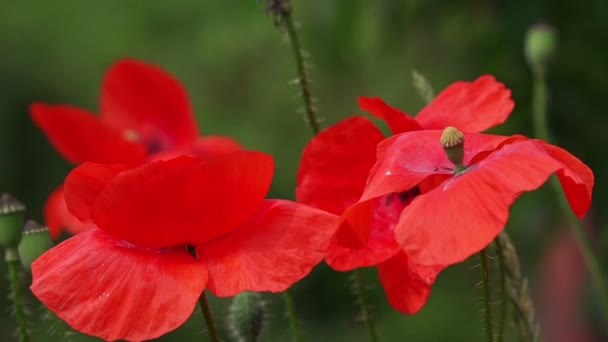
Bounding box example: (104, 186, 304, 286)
(267, 0, 321, 134)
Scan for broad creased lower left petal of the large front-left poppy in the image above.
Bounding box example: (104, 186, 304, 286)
(31, 229, 207, 341)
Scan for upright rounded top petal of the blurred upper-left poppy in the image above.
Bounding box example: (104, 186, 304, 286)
(100, 59, 198, 150)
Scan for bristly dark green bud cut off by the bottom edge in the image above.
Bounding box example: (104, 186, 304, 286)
(228, 292, 266, 342)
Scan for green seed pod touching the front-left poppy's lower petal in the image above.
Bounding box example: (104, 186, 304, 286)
(18, 220, 53, 270)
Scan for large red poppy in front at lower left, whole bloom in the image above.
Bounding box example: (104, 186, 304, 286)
(31, 151, 338, 341)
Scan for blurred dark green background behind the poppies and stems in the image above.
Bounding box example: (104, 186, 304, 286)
(0, 0, 608, 341)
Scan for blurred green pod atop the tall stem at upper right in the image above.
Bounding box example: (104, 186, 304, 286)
(524, 24, 557, 74)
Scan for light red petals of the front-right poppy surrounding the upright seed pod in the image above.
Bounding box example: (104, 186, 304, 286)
(341, 130, 594, 265)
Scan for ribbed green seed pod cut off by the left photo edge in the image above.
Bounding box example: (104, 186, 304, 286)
(0, 193, 25, 248)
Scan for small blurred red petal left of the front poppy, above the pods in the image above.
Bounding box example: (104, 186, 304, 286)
(44, 186, 95, 238)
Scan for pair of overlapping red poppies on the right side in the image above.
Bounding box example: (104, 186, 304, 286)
(296, 76, 593, 314)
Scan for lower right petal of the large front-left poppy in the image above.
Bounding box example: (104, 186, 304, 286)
(198, 200, 338, 296)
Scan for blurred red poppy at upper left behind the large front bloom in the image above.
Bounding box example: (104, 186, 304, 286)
(30, 59, 240, 237)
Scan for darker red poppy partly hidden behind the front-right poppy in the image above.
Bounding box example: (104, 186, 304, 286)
(296, 75, 513, 314)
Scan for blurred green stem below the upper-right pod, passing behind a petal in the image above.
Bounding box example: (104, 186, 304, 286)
(532, 71, 608, 317)
